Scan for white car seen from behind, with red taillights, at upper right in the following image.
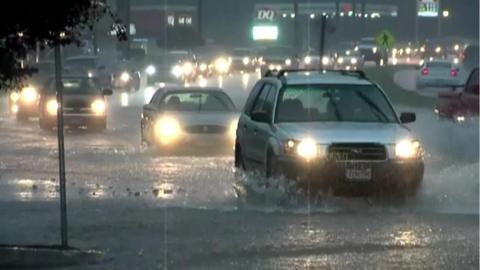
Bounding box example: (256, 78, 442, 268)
(417, 59, 459, 89)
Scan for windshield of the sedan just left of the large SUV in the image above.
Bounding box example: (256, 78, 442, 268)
(160, 92, 235, 112)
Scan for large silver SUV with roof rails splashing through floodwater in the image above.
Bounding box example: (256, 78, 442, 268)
(235, 70, 424, 196)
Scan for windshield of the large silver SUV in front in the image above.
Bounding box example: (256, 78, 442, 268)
(276, 85, 397, 123)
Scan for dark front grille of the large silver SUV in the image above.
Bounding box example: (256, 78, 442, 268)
(328, 143, 387, 161)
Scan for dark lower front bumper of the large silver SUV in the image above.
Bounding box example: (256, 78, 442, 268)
(279, 158, 424, 196)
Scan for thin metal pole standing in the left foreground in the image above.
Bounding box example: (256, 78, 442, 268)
(55, 44, 68, 248)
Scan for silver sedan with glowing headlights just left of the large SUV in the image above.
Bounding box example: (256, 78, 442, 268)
(140, 88, 238, 152)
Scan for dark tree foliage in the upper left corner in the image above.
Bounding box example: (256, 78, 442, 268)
(0, 0, 126, 89)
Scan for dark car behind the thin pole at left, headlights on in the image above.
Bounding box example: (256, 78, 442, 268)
(38, 75, 112, 131)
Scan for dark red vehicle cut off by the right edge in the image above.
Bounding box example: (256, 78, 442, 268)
(435, 68, 479, 122)
